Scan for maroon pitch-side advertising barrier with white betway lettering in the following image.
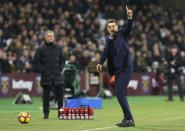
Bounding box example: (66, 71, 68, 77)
(0, 73, 185, 97)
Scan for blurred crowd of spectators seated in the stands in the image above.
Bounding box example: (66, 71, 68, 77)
(0, 0, 185, 73)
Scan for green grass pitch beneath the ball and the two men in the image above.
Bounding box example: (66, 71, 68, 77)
(0, 96, 185, 131)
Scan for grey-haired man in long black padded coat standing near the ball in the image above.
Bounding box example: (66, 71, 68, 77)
(33, 30, 65, 119)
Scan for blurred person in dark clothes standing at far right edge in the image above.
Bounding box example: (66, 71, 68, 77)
(164, 45, 184, 101)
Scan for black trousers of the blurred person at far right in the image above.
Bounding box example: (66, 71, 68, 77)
(167, 75, 184, 101)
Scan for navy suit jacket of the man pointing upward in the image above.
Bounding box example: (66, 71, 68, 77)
(99, 20, 133, 75)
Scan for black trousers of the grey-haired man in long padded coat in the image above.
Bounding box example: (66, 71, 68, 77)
(43, 79, 64, 115)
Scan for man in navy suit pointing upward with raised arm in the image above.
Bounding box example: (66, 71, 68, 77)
(97, 6, 135, 127)
